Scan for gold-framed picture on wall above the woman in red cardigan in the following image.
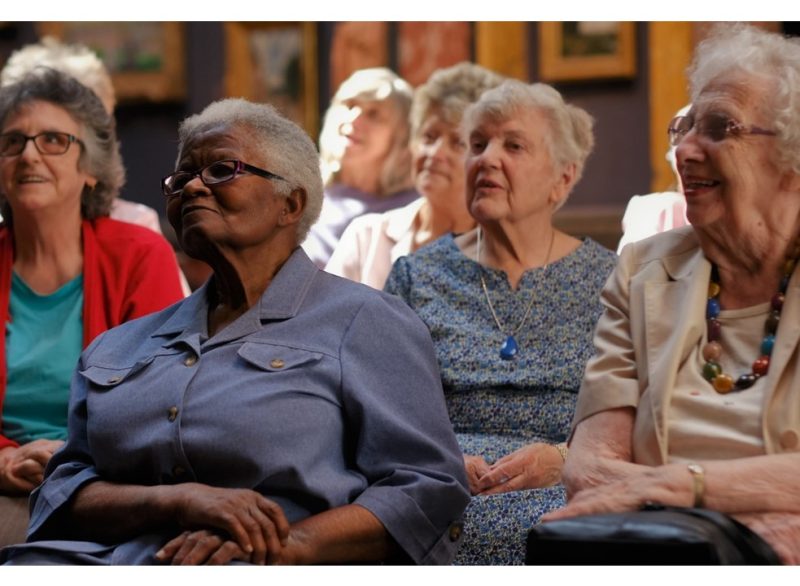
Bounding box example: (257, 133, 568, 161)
(36, 22, 186, 102)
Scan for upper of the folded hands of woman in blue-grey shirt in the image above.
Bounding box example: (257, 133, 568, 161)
(173, 483, 289, 564)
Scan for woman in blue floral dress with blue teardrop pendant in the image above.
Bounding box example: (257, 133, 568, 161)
(386, 81, 615, 564)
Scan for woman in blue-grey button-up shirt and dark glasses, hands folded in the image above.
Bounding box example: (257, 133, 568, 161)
(0, 99, 468, 564)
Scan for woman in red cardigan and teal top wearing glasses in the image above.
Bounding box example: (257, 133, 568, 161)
(0, 69, 183, 544)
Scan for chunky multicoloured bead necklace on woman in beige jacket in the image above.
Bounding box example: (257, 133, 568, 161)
(703, 256, 797, 395)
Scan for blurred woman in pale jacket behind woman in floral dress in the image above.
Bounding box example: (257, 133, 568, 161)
(325, 63, 503, 289)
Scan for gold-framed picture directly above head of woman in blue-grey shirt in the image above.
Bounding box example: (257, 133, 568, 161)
(225, 22, 319, 139)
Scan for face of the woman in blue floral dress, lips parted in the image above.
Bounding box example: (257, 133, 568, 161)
(466, 109, 574, 224)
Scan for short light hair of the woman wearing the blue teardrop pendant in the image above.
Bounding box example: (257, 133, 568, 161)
(462, 79, 594, 207)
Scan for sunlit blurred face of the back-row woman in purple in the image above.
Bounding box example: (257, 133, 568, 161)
(339, 99, 399, 167)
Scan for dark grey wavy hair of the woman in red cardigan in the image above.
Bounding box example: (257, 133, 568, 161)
(0, 67, 125, 221)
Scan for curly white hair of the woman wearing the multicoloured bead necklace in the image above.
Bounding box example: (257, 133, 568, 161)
(688, 23, 800, 174)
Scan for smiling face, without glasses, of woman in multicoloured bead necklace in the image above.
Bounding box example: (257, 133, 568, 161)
(675, 76, 786, 229)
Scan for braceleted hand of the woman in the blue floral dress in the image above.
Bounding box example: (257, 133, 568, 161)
(477, 443, 564, 495)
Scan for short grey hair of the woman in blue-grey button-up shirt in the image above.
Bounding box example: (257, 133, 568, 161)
(178, 98, 322, 243)
